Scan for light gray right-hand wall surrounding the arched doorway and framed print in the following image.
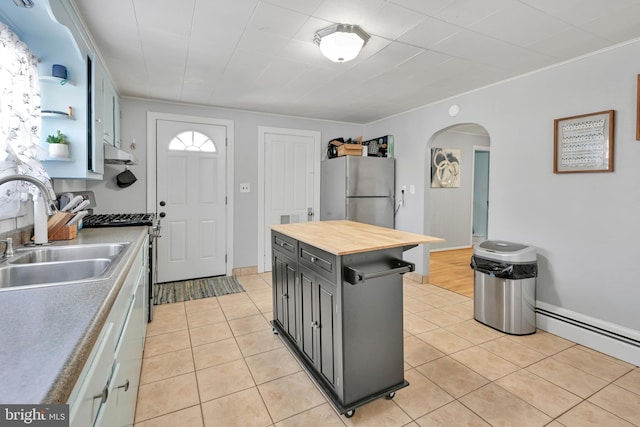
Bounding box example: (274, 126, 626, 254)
(367, 41, 640, 331)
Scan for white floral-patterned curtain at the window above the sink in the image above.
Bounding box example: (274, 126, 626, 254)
(0, 22, 51, 219)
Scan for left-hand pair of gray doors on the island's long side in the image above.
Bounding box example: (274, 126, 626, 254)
(272, 251, 300, 342)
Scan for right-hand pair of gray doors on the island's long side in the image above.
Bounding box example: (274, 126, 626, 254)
(299, 266, 336, 387)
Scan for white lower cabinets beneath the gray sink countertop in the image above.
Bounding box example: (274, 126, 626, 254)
(69, 239, 148, 427)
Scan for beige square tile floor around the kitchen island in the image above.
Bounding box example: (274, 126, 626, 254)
(135, 274, 640, 427)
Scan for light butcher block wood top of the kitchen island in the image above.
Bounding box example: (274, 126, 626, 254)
(270, 221, 444, 255)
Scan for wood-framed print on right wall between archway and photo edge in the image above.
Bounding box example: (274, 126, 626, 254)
(553, 110, 615, 173)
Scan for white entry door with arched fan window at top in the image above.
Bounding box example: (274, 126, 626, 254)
(156, 120, 226, 283)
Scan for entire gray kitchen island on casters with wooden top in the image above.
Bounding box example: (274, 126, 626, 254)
(271, 221, 442, 417)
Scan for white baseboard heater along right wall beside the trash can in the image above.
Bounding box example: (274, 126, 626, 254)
(536, 301, 640, 366)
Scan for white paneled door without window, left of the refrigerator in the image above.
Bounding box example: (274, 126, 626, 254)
(261, 128, 320, 271)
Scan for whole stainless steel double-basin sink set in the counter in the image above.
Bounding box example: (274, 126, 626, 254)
(0, 242, 130, 292)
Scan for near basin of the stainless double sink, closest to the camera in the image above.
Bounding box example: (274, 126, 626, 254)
(0, 258, 113, 291)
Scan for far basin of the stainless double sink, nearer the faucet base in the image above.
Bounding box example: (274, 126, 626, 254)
(8, 243, 128, 264)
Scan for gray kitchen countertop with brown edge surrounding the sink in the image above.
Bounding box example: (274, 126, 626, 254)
(0, 227, 148, 404)
